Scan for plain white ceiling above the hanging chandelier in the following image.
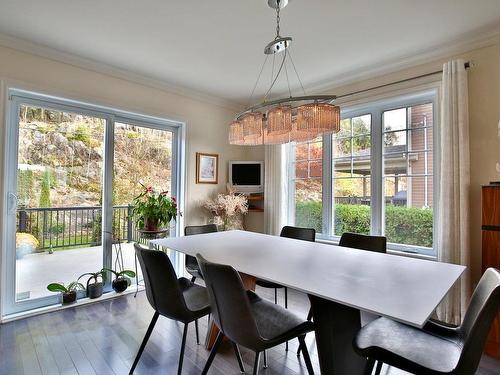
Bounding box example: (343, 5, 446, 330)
(0, 0, 500, 103)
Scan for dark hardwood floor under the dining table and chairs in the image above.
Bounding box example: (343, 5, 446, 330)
(0, 288, 500, 375)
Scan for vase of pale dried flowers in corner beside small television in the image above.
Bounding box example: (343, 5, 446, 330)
(203, 187, 248, 230)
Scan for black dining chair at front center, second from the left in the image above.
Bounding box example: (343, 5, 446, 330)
(196, 254, 314, 375)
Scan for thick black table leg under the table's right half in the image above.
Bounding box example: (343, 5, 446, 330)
(309, 295, 366, 375)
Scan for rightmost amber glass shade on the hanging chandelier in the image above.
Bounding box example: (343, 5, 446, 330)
(297, 103, 340, 138)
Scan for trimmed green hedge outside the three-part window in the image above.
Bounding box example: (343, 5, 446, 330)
(295, 201, 432, 247)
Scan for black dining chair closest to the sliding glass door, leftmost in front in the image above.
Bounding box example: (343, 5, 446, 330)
(129, 243, 210, 375)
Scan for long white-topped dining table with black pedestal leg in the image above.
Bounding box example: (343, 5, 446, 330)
(150, 230, 465, 375)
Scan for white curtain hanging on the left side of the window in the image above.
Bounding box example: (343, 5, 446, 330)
(264, 145, 288, 235)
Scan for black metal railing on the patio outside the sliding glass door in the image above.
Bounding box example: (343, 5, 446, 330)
(17, 205, 140, 249)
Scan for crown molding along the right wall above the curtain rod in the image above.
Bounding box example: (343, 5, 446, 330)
(306, 24, 500, 94)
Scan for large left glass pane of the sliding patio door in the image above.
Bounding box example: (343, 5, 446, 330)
(16, 105, 105, 301)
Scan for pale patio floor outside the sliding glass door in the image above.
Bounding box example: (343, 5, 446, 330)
(16, 243, 150, 300)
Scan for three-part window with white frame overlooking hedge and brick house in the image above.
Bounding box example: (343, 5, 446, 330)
(289, 90, 436, 256)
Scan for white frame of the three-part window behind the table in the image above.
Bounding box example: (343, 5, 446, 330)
(288, 87, 439, 258)
